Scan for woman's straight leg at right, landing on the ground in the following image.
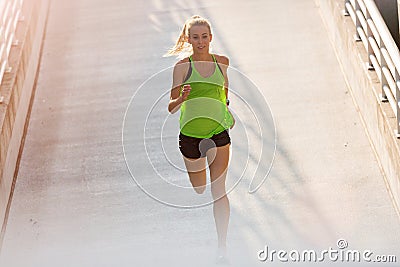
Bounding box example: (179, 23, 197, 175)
(207, 144, 230, 253)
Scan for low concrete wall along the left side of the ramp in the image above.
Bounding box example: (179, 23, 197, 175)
(0, 0, 49, 232)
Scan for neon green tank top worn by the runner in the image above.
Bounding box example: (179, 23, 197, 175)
(179, 55, 233, 138)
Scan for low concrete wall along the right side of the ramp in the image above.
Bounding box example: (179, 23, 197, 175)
(315, 0, 400, 212)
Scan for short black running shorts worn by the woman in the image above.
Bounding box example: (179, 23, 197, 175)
(179, 130, 231, 159)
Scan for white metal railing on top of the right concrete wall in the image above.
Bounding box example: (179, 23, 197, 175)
(345, 0, 400, 138)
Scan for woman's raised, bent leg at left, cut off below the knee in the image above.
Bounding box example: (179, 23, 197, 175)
(183, 157, 206, 194)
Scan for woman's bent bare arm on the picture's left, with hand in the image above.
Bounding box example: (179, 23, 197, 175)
(168, 60, 190, 113)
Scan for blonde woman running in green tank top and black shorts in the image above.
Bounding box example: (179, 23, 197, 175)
(166, 16, 234, 261)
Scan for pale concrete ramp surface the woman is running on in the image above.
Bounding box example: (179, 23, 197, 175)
(0, 0, 400, 267)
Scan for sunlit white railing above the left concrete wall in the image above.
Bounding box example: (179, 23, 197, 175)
(0, 0, 23, 88)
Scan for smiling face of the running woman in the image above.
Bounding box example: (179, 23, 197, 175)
(188, 25, 212, 54)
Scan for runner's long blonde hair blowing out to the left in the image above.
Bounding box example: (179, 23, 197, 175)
(164, 15, 211, 57)
